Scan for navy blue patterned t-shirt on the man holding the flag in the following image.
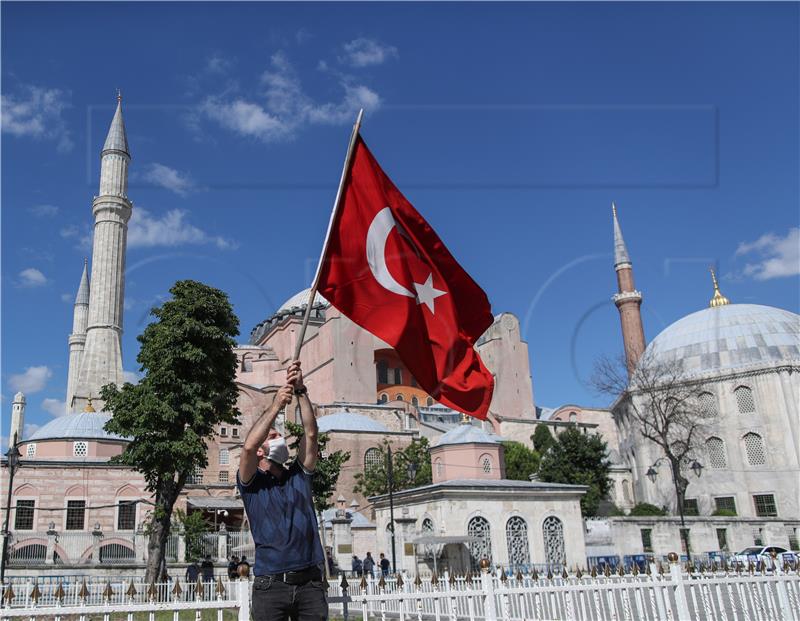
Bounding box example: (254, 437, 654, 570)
(236, 461, 324, 576)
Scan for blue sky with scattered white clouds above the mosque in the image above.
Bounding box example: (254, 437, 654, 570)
(1, 3, 800, 433)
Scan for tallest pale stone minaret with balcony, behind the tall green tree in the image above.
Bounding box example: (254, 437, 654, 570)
(69, 95, 133, 412)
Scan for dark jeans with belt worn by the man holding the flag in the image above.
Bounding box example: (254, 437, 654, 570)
(253, 576, 328, 621)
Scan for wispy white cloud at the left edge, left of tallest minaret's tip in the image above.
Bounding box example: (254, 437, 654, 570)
(0, 85, 73, 151)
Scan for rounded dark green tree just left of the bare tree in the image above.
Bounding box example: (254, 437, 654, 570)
(539, 427, 611, 516)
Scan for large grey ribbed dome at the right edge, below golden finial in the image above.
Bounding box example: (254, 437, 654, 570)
(646, 304, 800, 377)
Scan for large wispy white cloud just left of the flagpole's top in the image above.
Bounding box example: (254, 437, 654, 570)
(192, 52, 381, 142)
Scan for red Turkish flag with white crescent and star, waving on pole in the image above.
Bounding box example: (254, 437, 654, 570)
(318, 136, 494, 419)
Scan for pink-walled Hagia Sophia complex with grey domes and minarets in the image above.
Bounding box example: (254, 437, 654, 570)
(2, 95, 800, 574)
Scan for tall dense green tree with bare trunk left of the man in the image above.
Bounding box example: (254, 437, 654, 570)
(100, 280, 239, 582)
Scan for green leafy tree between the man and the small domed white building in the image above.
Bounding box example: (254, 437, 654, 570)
(353, 438, 432, 497)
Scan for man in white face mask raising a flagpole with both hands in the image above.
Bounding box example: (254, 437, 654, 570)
(236, 361, 328, 621)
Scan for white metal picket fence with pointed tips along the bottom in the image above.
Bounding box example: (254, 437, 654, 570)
(0, 562, 800, 621)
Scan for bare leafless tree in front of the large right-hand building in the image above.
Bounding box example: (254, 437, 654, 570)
(591, 350, 716, 551)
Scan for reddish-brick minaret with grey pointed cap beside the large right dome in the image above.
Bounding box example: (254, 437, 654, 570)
(611, 203, 646, 376)
